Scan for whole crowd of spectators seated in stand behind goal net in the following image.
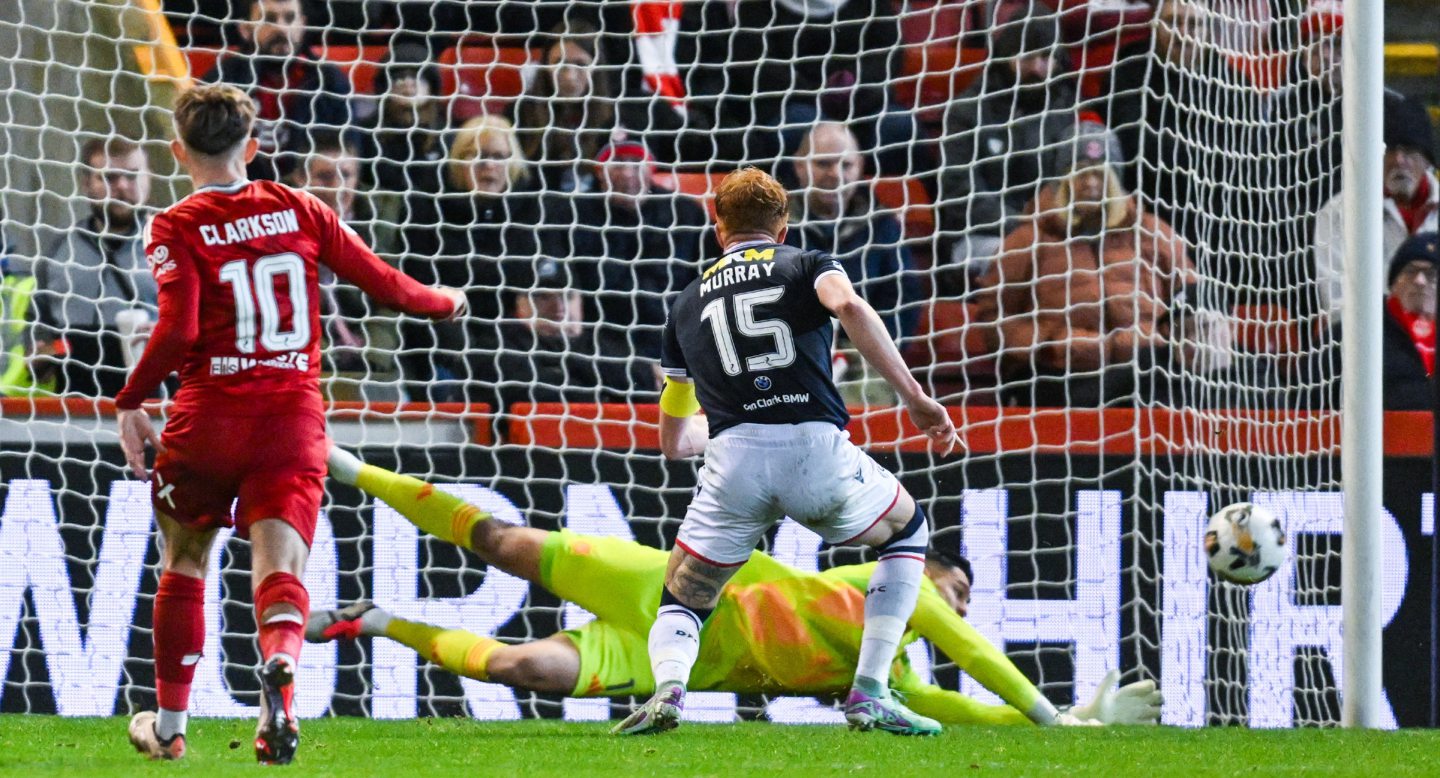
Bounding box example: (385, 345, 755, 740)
(0, 0, 1440, 408)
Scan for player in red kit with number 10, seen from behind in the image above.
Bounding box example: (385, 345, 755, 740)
(115, 85, 465, 764)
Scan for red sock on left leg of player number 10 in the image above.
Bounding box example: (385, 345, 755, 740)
(154, 572, 204, 710)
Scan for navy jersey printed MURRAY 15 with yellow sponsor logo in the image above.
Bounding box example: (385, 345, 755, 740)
(660, 243, 850, 437)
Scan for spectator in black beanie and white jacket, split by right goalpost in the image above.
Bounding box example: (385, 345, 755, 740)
(1315, 91, 1440, 318)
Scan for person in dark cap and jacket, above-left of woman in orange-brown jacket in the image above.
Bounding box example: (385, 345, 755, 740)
(937, 6, 1076, 277)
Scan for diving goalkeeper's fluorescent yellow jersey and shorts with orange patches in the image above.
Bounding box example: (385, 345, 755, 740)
(541, 530, 1041, 723)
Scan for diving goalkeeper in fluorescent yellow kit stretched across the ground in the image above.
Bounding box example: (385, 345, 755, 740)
(305, 448, 1161, 725)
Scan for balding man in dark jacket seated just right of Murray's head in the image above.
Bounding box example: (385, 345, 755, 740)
(785, 121, 920, 340)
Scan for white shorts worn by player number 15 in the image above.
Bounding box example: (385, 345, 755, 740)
(675, 422, 900, 566)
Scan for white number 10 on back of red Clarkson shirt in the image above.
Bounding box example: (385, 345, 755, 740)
(220, 254, 310, 354)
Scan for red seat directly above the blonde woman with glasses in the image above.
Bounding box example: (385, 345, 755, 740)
(439, 42, 539, 122)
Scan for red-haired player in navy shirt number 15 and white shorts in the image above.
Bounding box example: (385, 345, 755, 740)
(615, 167, 956, 735)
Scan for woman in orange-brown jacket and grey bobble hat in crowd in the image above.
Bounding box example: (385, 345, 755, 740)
(975, 122, 1197, 408)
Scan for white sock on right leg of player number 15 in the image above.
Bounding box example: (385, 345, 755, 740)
(855, 504, 930, 694)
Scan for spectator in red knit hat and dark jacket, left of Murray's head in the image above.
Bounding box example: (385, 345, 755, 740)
(543, 140, 720, 362)
